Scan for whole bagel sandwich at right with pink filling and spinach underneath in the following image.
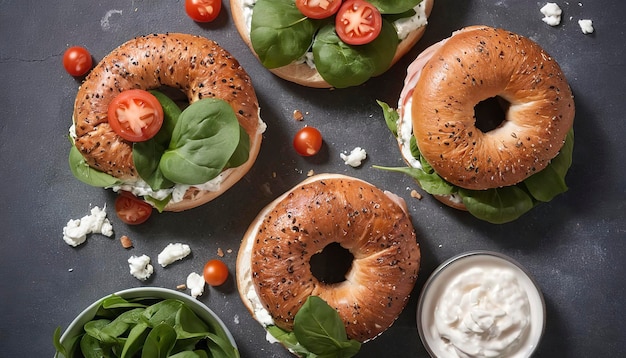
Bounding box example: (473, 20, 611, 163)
(378, 26, 575, 223)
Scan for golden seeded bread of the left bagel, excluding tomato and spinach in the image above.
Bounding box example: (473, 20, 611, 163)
(73, 33, 265, 211)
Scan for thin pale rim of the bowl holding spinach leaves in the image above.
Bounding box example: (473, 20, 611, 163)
(61, 287, 237, 356)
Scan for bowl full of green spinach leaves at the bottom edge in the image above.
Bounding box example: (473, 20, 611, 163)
(54, 287, 239, 358)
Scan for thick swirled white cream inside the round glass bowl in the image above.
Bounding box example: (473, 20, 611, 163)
(418, 255, 544, 358)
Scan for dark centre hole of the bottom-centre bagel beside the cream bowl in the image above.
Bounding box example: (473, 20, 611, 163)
(309, 242, 354, 285)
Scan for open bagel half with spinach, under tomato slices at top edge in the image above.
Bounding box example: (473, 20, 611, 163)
(230, 0, 434, 88)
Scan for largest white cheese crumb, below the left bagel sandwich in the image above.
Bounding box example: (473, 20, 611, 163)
(63, 205, 113, 247)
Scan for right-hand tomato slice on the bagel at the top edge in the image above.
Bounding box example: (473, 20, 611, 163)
(335, 0, 383, 45)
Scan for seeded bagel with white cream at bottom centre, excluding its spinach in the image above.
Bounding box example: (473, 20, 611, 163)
(237, 174, 420, 350)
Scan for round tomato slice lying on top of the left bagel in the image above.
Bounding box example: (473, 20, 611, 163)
(108, 89, 163, 142)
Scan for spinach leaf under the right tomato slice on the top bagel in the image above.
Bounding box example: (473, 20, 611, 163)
(313, 19, 398, 88)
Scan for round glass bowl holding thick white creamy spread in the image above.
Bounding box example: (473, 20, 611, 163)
(417, 251, 546, 358)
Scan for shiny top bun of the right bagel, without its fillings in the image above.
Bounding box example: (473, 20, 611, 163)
(411, 26, 574, 190)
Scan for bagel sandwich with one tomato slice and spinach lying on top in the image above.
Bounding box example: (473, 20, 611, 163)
(69, 33, 265, 211)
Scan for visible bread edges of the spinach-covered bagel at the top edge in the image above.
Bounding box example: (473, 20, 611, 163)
(230, 0, 434, 88)
